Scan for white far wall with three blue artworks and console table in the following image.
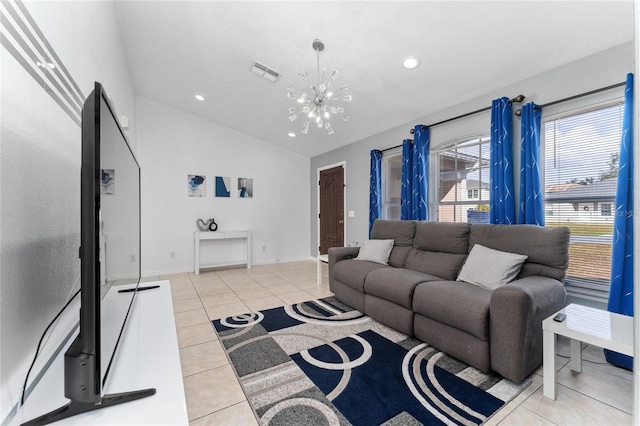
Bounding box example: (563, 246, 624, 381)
(137, 97, 310, 276)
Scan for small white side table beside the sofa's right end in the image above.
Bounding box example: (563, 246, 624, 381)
(542, 303, 633, 399)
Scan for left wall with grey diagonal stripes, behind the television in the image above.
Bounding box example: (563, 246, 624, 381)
(0, 1, 135, 421)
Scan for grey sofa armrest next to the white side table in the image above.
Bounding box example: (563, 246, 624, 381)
(489, 276, 567, 383)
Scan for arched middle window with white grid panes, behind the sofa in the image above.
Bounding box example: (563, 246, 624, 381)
(434, 137, 489, 223)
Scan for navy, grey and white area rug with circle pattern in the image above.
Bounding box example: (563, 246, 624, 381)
(213, 297, 530, 426)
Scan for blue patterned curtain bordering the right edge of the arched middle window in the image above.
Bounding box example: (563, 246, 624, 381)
(489, 97, 516, 225)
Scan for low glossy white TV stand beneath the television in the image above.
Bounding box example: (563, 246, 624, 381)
(10, 281, 189, 425)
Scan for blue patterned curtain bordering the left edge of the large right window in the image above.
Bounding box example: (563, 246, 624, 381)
(518, 102, 544, 226)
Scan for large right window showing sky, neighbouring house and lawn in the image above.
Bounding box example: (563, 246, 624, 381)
(543, 103, 624, 290)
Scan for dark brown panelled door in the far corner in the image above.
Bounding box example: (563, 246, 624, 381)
(319, 166, 344, 254)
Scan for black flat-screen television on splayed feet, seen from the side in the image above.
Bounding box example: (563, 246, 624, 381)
(25, 82, 155, 424)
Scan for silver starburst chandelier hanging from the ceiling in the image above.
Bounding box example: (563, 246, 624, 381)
(287, 39, 351, 135)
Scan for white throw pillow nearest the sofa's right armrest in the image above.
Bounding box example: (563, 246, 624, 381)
(458, 244, 528, 290)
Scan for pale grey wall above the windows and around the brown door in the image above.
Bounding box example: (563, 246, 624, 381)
(309, 43, 634, 255)
